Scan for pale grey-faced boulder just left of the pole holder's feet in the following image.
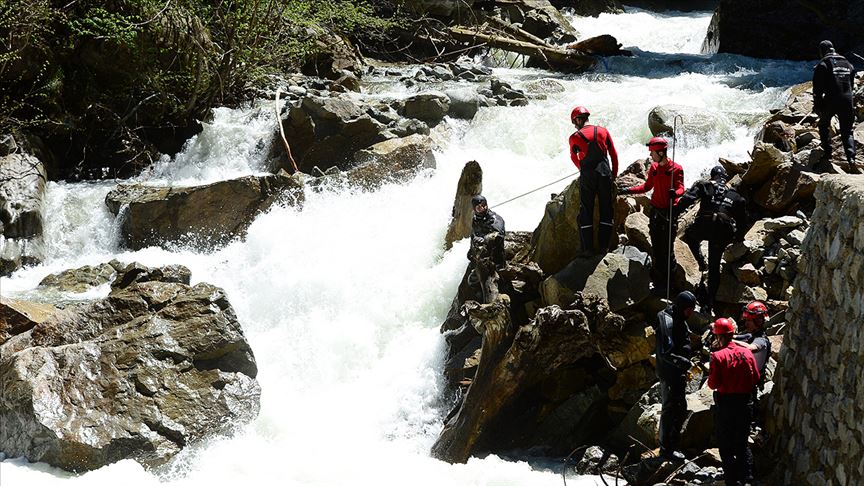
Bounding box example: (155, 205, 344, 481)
(541, 246, 651, 311)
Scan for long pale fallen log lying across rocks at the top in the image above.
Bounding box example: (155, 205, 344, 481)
(449, 27, 597, 71)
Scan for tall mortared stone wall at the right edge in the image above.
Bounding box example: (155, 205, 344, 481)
(768, 176, 864, 486)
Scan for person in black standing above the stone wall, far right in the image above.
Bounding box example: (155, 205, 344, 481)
(813, 40, 855, 170)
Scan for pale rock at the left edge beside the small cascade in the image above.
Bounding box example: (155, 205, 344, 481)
(0, 154, 48, 275)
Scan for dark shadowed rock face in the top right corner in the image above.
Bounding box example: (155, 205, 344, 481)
(702, 0, 864, 60)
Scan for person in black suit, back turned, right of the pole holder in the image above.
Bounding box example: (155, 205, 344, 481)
(675, 165, 747, 312)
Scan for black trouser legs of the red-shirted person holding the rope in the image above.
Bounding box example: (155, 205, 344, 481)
(577, 170, 613, 253)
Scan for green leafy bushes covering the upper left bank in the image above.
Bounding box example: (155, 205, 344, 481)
(0, 0, 396, 175)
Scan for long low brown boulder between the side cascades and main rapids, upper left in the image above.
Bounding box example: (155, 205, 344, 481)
(105, 173, 303, 250)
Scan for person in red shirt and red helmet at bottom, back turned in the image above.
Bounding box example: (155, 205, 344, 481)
(708, 318, 759, 486)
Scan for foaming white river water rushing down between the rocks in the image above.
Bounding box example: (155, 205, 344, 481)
(0, 7, 807, 486)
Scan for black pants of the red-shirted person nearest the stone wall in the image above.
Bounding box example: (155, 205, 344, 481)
(714, 392, 753, 485)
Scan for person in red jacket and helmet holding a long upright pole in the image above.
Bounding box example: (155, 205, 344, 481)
(620, 137, 684, 291)
